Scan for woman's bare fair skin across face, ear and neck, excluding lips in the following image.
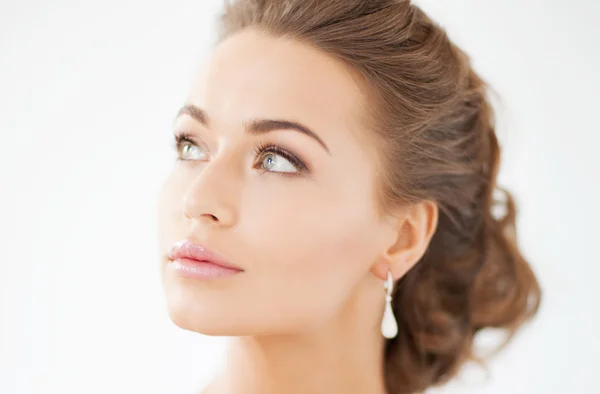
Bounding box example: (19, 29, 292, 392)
(159, 29, 437, 394)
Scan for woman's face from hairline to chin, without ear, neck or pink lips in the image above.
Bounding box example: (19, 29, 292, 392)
(159, 30, 394, 335)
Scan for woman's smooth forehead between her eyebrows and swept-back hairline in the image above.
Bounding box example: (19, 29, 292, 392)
(190, 29, 364, 146)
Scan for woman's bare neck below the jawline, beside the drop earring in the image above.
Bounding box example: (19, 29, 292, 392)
(204, 276, 386, 394)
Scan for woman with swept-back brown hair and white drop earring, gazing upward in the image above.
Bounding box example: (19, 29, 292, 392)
(160, 0, 540, 394)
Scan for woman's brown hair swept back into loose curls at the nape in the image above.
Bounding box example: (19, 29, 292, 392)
(218, 0, 541, 393)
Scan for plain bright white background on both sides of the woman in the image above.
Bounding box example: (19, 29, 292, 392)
(0, 0, 600, 394)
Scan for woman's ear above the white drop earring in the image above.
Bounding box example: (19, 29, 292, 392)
(371, 201, 439, 280)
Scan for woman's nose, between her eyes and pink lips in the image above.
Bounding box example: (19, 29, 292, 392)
(183, 160, 242, 227)
